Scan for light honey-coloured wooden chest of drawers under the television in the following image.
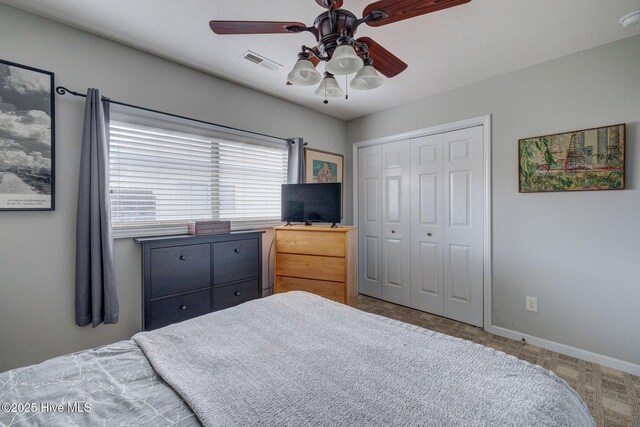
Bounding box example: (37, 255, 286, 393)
(274, 225, 358, 306)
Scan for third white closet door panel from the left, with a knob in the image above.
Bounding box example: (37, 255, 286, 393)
(411, 134, 444, 315)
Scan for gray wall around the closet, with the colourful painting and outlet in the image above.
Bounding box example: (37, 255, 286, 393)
(347, 36, 640, 364)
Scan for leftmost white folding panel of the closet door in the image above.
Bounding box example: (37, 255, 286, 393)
(358, 145, 382, 298)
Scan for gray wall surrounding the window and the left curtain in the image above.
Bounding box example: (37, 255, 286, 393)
(0, 5, 350, 372)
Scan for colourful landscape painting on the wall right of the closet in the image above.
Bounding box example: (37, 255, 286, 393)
(518, 123, 626, 193)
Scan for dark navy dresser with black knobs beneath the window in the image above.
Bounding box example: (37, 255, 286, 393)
(135, 231, 263, 330)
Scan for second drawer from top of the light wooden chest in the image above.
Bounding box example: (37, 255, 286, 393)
(276, 253, 345, 282)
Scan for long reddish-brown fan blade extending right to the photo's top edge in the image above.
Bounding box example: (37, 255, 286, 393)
(362, 0, 471, 27)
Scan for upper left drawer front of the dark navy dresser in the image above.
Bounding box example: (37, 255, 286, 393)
(150, 244, 211, 298)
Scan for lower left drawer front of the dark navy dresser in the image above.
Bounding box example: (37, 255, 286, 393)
(145, 290, 211, 331)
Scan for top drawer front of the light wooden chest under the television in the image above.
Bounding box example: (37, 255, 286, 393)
(276, 230, 345, 257)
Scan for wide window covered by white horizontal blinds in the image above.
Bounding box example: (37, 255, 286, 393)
(109, 109, 287, 237)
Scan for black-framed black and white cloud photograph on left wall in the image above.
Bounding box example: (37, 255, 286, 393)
(0, 59, 55, 210)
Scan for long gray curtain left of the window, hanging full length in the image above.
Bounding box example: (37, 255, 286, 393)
(76, 89, 119, 328)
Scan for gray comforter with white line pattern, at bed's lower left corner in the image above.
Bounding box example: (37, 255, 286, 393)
(0, 340, 200, 427)
